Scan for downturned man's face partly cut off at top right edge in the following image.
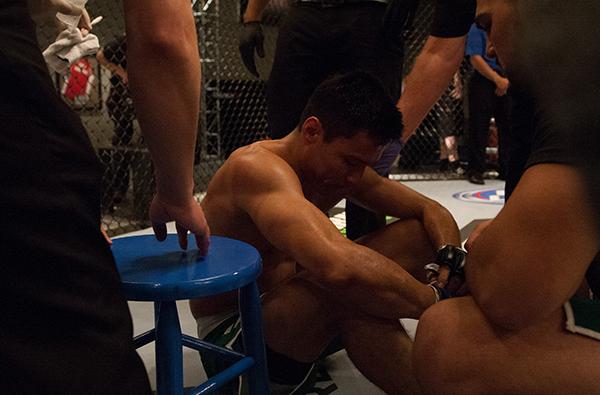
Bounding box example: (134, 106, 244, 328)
(475, 0, 519, 73)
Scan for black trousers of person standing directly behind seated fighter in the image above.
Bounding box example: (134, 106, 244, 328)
(267, 2, 403, 238)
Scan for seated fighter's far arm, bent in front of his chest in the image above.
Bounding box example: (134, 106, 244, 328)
(350, 167, 461, 248)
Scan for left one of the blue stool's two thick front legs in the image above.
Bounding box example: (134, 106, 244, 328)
(154, 301, 183, 395)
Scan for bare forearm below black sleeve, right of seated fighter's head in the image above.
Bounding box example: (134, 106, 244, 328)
(397, 36, 466, 142)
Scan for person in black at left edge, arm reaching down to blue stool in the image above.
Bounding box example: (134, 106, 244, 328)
(0, 0, 209, 395)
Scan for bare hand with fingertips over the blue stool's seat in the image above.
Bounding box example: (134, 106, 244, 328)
(150, 195, 210, 255)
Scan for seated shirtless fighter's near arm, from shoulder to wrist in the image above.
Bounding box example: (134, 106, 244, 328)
(231, 156, 435, 319)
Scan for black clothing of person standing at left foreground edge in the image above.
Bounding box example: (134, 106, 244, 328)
(0, 0, 150, 394)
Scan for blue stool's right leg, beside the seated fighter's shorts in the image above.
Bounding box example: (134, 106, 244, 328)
(239, 282, 271, 395)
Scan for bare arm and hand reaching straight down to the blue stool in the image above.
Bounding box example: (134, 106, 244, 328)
(125, 0, 209, 252)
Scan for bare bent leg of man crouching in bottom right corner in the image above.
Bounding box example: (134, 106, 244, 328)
(413, 297, 600, 395)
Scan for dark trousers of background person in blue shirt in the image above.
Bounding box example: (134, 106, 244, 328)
(467, 71, 508, 174)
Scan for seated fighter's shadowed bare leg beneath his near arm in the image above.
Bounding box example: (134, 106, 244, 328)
(263, 276, 419, 394)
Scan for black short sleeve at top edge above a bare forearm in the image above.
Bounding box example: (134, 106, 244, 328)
(431, 0, 476, 38)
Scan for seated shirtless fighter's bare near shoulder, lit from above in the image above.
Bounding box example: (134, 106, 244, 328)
(224, 140, 301, 193)
